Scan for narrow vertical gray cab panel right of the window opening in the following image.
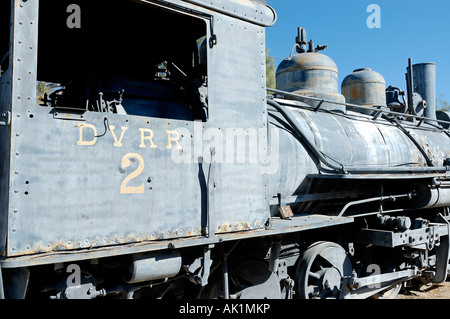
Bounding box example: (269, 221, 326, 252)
(205, 10, 269, 232)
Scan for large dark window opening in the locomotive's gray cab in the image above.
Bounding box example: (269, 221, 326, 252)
(37, 0, 208, 121)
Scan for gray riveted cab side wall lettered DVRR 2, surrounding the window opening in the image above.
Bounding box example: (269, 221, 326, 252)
(7, 1, 269, 256)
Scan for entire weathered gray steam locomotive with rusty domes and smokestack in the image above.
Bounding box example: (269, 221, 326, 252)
(0, 0, 450, 299)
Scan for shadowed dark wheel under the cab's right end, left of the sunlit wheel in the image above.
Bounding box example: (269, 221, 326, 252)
(204, 259, 281, 299)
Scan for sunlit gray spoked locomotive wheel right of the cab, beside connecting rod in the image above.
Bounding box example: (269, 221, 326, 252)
(296, 242, 352, 299)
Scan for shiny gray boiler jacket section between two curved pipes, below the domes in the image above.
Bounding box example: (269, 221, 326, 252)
(286, 110, 423, 167)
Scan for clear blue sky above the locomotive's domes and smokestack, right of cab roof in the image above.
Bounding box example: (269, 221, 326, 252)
(266, 0, 450, 102)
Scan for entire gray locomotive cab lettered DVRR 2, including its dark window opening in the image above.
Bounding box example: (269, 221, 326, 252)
(0, 0, 282, 298)
